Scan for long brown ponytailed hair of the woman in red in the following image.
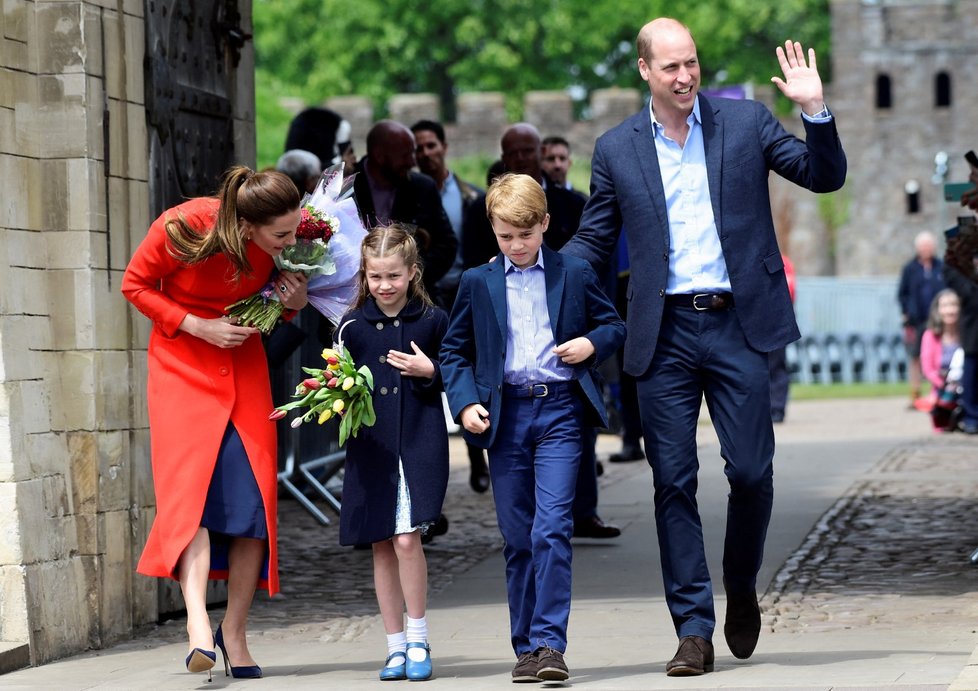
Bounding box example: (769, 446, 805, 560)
(165, 166, 299, 280)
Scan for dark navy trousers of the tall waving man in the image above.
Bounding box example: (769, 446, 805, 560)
(637, 305, 774, 640)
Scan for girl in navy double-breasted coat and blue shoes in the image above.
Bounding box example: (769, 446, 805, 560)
(338, 224, 448, 681)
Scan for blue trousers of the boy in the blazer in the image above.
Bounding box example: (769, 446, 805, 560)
(489, 383, 583, 655)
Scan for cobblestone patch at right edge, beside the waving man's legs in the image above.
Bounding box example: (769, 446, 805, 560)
(761, 435, 978, 633)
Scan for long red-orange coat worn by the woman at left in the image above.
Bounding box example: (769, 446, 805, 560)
(122, 198, 278, 594)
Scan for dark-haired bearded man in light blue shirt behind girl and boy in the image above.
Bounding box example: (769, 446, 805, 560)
(411, 120, 489, 494)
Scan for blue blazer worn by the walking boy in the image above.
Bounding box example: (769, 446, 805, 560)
(441, 246, 625, 449)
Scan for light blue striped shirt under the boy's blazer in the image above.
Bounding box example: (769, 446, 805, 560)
(503, 252, 573, 385)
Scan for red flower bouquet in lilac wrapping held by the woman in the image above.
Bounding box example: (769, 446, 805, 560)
(225, 163, 367, 334)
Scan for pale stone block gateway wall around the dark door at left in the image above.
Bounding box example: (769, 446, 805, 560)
(0, 0, 264, 673)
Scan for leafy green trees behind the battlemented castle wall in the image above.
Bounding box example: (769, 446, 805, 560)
(253, 0, 829, 162)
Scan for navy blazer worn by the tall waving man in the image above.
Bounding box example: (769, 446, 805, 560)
(562, 94, 846, 376)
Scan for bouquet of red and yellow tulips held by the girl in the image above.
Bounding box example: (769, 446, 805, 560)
(268, 343, 377, 446)
